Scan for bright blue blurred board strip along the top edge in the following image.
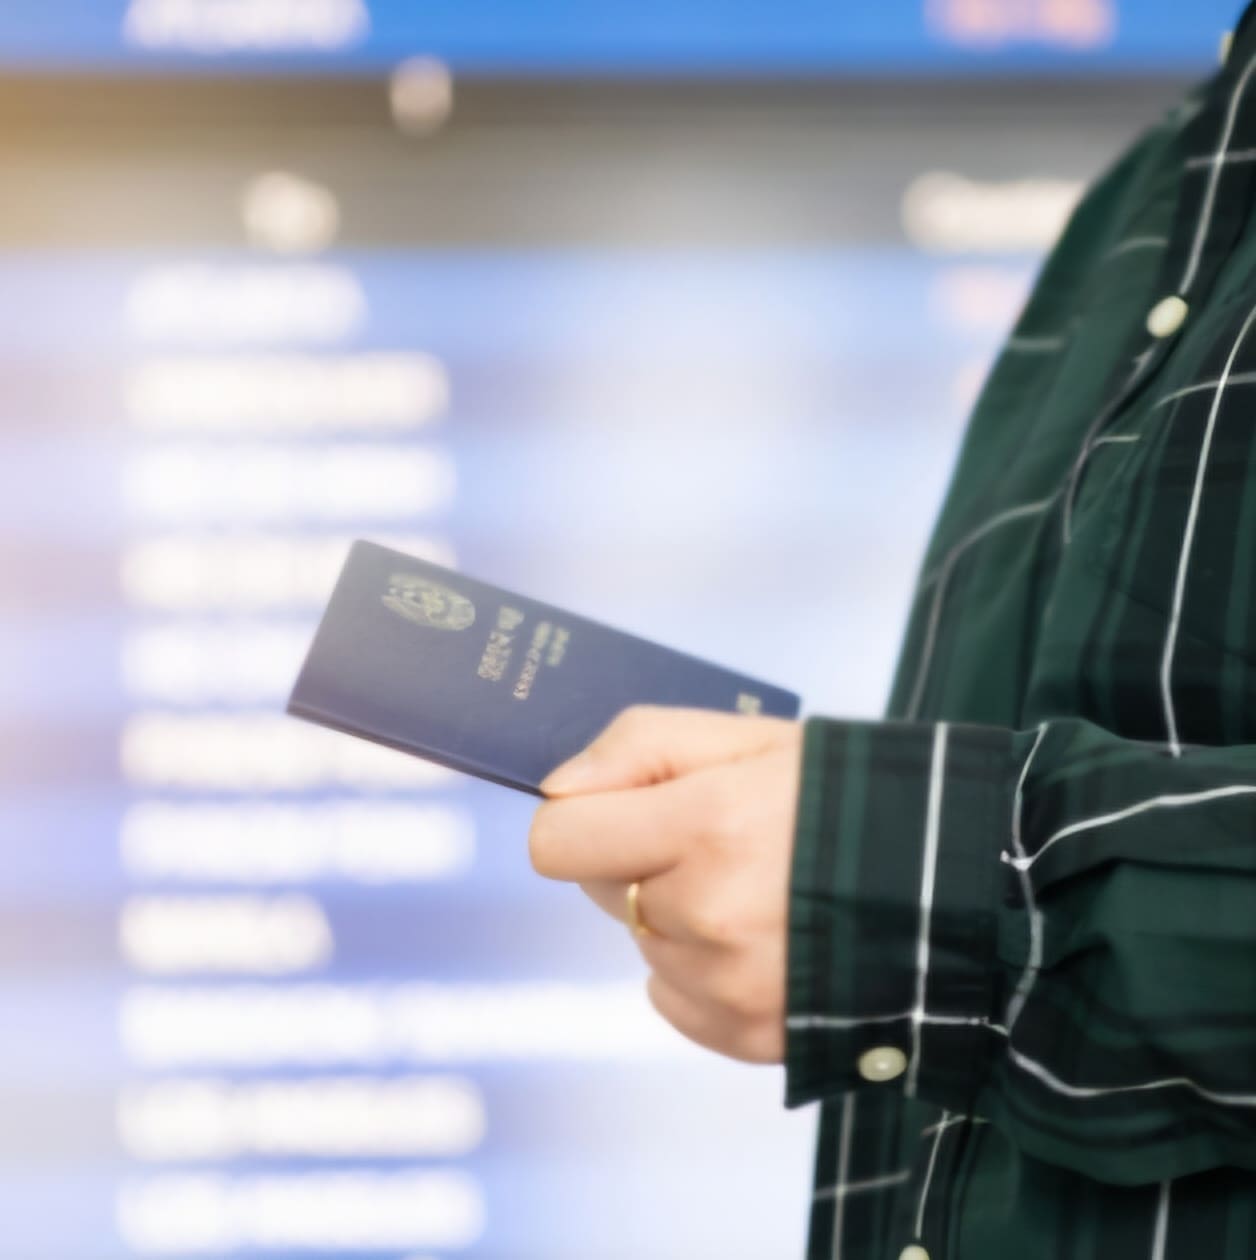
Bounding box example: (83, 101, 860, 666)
(0, 0, 1241, 74)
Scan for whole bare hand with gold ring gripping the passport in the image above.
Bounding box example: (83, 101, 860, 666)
(528, 706, 802, 1063)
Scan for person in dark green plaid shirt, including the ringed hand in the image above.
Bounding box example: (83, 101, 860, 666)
(529, 6, 1256, 1260)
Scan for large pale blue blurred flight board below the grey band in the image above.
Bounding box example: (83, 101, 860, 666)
(0, 249, 1028, 1260)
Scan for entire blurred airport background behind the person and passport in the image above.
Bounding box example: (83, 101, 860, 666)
(0, 0, 1236, 1260)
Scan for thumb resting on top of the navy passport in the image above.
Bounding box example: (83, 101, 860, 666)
(540, 704, 797, 796)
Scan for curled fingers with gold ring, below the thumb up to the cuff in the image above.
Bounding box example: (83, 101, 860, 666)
(546, 723, 800, 1062)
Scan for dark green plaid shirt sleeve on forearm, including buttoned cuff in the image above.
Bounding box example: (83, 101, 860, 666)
(785, 718, 1256, 1184)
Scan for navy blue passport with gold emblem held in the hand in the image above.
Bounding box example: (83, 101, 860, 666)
(287, 542, 799, 795)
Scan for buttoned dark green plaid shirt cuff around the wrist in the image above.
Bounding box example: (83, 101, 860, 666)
(785, 718, 1013, 1111)
